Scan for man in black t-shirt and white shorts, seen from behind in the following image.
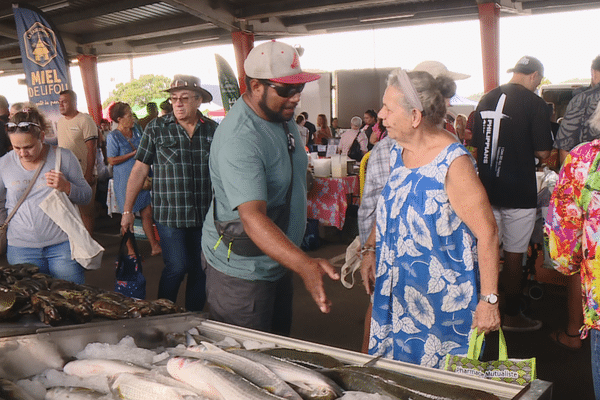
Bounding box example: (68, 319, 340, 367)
(471, 56, 552, 331)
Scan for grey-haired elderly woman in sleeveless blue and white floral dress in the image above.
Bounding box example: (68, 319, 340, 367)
(361, 70, 500, 367)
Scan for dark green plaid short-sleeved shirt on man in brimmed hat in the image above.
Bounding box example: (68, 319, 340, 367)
(135, 112, 217, 228)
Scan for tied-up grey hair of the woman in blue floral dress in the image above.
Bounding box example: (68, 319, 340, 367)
(387, 69, 456, 125)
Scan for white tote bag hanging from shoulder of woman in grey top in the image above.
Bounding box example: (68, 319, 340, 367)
(40, 147, 104, 269)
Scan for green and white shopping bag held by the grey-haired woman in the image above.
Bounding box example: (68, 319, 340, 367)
(444, 329, 536, 385)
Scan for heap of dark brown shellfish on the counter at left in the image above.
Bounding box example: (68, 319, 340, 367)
(0, 264, 183, 325)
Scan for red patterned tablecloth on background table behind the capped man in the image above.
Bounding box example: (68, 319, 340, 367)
(307, 175, 359, 229)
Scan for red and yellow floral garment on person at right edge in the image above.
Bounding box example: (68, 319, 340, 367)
(544, 140, 600, 338)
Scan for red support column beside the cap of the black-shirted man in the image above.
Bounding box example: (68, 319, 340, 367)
(479, 3, 500, 93)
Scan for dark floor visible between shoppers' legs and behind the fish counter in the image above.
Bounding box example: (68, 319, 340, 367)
(0, 215, 594, 400)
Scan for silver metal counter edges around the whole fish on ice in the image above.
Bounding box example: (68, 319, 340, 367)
(0, 313, 552, 400)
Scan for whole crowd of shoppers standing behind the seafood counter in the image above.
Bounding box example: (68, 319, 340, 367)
(0, 41, 600, 398)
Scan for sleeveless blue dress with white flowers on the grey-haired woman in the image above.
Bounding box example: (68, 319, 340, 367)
(369, 143, 479, 367)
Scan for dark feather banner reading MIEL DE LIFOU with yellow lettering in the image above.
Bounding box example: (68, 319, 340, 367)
(13, 4, 71, 136)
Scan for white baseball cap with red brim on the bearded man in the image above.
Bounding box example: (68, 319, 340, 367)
(244, 40, 321, 85)
